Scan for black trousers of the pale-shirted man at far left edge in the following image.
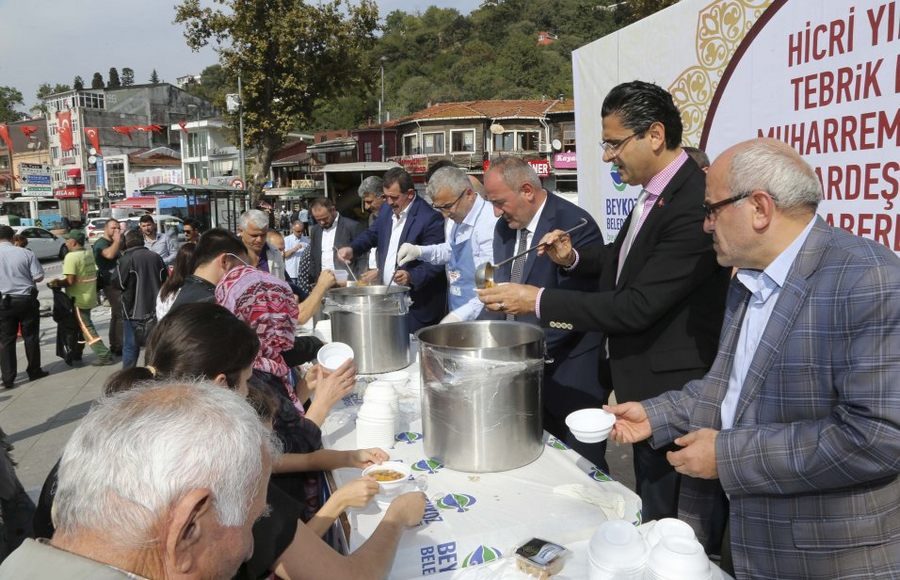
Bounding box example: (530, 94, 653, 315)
(0, 296, 41, 386)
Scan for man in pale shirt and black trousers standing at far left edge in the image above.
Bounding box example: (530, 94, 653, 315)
(0, 225, 49, 389)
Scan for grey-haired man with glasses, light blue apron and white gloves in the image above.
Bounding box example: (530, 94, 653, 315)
(397, 167, 497, 323)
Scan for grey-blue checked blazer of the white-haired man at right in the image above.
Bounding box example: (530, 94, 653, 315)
(644, 218, 900, 579)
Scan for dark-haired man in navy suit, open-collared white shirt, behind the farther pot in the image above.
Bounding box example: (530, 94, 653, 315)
(338, 167, 447, 332)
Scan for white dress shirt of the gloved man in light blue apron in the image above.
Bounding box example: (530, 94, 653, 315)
(419, 195, 497, 320)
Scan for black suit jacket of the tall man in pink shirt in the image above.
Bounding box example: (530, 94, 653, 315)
(540, 159, 730, 403)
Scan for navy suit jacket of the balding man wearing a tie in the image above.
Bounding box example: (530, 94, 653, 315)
(479, 193, 608, 418)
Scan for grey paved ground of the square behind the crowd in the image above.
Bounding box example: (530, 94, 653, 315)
(0, 261, 634, 498)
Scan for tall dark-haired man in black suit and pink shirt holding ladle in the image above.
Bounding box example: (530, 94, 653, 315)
(482, 81, 729, 524)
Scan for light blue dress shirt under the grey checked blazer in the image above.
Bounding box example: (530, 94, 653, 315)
(720, 217, 816, 429)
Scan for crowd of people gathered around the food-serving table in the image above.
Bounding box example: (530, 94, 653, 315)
(0, 81, 900, 578)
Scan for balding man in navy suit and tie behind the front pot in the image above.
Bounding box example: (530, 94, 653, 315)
(481, 157, 609, 471)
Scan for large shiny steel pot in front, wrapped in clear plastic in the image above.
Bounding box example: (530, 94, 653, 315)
(416, 320, 544, 472)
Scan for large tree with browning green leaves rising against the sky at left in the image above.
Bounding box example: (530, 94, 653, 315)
(175, 0, 378, 201)
